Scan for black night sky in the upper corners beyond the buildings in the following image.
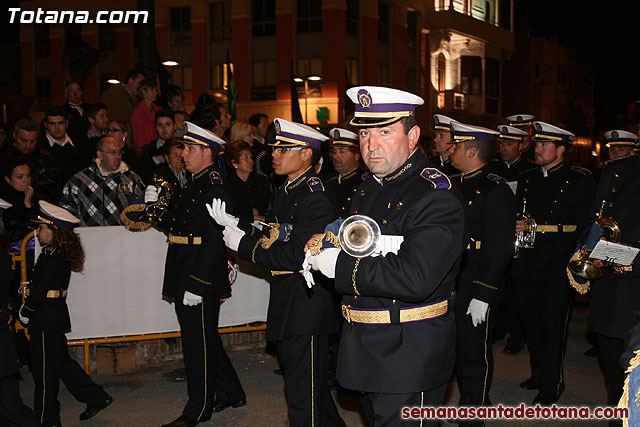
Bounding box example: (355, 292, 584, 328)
(0, 0, 640, 132)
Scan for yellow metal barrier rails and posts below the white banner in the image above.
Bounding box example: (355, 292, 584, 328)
(11, 231, 267, 373)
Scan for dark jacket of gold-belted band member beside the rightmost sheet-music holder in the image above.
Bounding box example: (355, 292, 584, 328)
(512, 162, 594, 279)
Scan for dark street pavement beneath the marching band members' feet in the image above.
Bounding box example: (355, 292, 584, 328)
(21, 303, 620, 427)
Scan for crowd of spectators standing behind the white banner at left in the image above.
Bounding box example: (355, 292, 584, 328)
(0, 69, 279, 251)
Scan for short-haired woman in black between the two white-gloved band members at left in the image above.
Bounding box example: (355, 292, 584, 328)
(224, 141, 273, 226)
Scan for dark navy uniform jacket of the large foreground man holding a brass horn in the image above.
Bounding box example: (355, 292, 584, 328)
(335, 152, 464, 393)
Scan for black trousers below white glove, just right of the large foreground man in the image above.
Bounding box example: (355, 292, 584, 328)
(455, 305, 495, 426)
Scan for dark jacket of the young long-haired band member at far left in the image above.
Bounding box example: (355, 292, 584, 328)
(22, 246, 71, 332)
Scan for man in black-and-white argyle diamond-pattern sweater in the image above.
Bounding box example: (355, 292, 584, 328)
(60, 136, 144, 227)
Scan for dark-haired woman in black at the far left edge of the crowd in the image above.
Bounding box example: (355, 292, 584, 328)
(0, 156, 40, 248)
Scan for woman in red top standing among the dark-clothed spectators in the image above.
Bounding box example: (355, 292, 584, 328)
(131, 80, 161, 147)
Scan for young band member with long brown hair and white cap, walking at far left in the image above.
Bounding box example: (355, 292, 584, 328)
(19, 201, 113, 427)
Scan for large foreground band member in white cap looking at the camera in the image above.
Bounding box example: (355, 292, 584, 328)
(307, 86, 464, 426)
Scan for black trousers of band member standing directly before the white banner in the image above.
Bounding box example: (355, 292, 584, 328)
(175, 296, 247, 421)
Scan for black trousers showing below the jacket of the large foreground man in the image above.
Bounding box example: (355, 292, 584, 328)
(360, 383, 447, 427)
